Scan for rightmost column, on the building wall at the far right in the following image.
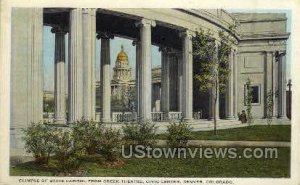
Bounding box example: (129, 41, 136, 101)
(278, 52, 287, 119)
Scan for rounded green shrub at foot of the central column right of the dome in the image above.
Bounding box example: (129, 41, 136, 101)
(122, 121, 157, 147)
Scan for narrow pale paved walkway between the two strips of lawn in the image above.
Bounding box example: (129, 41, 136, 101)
(157, 140, 291, 147)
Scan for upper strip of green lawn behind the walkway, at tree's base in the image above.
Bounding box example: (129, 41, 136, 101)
(157, 125, 291, 141)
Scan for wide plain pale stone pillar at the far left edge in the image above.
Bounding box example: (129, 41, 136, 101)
(10, 8, 43, 159)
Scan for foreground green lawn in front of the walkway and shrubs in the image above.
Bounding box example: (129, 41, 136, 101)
(10, 148, 290, 178)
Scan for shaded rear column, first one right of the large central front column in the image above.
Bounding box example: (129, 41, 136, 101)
(160, 48, 170, 113)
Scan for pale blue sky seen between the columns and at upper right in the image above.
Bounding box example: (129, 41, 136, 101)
(43, 9, 292, 91)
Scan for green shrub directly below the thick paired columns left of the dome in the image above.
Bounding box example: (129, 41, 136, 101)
(72, 119, 103, 154)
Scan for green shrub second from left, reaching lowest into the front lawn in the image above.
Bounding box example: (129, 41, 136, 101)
(55, 128, 85, 173)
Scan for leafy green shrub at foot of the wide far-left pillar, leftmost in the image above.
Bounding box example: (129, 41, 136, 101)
(23, 123, 57, 164)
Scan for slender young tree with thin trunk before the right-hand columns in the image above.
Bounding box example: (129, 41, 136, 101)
(193, 26, 235, 135)
